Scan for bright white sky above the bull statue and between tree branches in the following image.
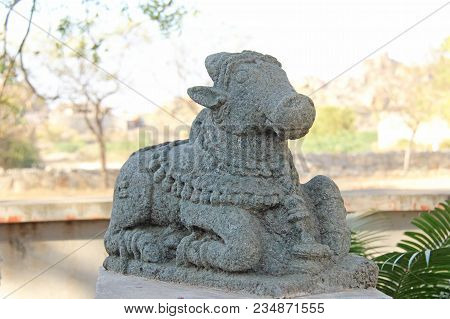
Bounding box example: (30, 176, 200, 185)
(2, 0, 450, 113)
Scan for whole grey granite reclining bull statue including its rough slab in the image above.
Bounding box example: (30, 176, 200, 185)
(104, 51, 377, 296)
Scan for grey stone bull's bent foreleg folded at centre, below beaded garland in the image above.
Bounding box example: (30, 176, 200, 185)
(177, 202, 261, 271)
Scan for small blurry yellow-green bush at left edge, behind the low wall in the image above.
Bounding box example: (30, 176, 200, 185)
(0, 138, 39, 169)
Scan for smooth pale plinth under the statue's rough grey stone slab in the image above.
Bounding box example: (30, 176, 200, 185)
(95, 267, 390, 299)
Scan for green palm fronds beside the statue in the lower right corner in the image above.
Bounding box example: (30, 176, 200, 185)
(374, 201, 450, 299)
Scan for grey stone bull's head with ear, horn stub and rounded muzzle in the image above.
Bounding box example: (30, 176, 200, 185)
(188, 51, 315, 140)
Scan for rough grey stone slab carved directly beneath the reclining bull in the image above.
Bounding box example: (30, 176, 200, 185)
(103, 254, 378, 298)
